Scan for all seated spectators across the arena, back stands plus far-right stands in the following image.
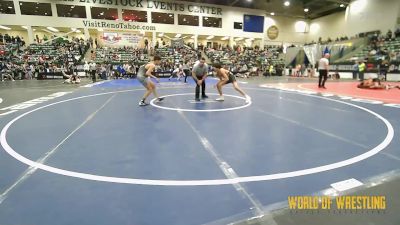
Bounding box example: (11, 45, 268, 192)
(6, 29, 400, 80)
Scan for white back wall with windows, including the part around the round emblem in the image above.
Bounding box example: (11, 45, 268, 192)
(0, 0, 305, 45)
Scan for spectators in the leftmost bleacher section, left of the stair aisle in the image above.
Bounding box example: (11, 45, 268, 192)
(0, 35, 88, 81)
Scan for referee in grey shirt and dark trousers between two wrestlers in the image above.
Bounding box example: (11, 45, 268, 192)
(192, 58, 208, 101)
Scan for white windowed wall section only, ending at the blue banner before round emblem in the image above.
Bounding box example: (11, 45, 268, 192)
(0, 0, 264, 38)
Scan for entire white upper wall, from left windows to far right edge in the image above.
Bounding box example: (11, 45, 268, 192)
(0, 0, 400, 44)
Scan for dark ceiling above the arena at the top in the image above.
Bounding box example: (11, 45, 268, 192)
(180, 0, 350, 19)
